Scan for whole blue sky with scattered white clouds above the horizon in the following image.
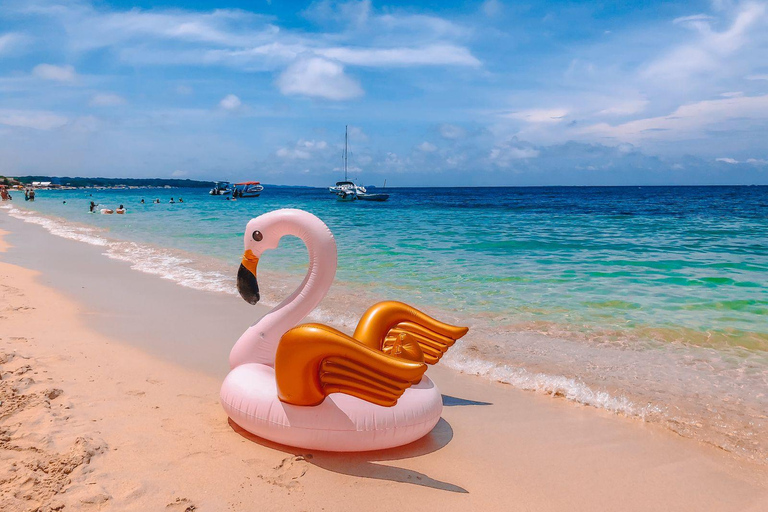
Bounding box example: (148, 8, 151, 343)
(0, 0, 768, 186)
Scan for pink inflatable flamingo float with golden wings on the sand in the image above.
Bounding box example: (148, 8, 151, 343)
(221, 209, 468, 452)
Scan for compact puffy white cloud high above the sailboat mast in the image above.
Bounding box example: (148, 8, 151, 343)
(277, 57, 363, 101)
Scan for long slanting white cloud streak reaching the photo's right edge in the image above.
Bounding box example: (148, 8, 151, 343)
(580, 95, 768, 141)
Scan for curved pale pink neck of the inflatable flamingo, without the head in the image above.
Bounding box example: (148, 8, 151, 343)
(229, 219, 336, 368)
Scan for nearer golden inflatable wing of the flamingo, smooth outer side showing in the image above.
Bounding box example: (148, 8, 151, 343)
(275, 324, 427, 407)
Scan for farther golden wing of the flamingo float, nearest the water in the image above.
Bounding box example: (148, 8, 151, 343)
(353, 301, 469, 364)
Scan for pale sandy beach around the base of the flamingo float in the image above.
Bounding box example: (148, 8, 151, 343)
(0, 216, 768, 512)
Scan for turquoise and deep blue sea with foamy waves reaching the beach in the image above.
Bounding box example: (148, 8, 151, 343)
(1, 187, 768, 461)
